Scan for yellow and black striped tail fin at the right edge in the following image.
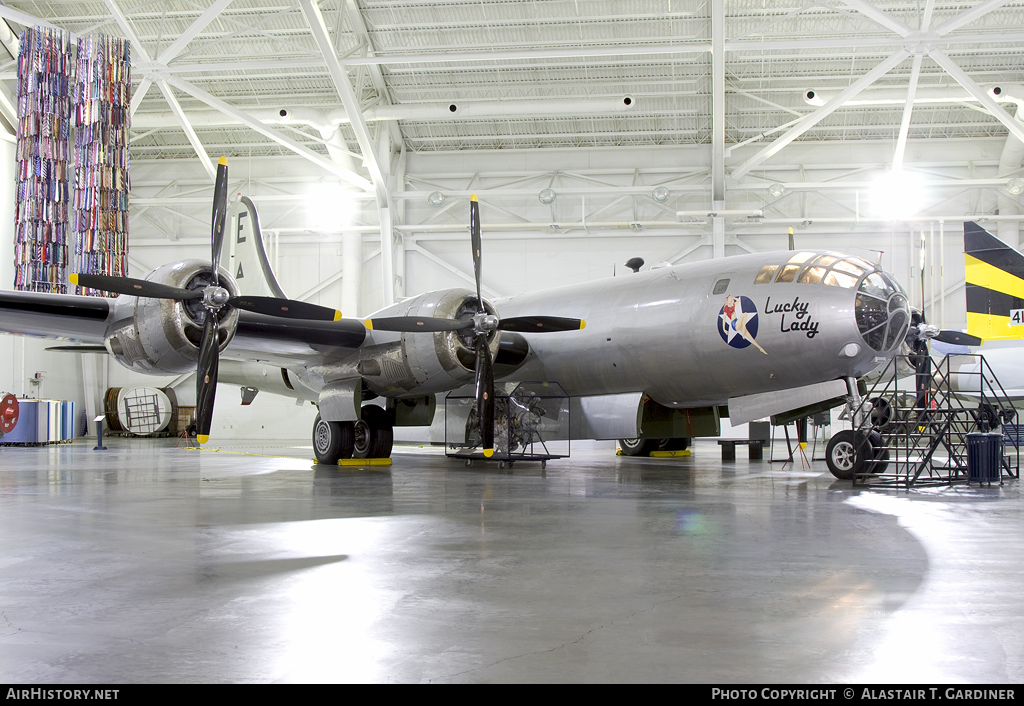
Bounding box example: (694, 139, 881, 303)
(964, 221, 1024, 340)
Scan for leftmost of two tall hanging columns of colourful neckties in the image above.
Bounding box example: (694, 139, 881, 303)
(14, 27, 75, 293)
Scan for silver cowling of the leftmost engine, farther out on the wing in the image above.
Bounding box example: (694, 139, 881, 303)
(106, 260, 239, 374)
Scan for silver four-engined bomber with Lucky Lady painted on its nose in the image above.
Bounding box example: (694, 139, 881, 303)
(0, 156, 911, 471)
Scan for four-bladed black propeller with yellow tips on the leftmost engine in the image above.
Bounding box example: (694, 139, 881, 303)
(69, 157, 341, 444)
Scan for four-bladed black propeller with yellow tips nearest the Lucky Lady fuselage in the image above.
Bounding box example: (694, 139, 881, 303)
(366, 194, 587, 458)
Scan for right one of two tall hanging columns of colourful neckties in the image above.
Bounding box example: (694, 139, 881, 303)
(72, 35, 131, 296)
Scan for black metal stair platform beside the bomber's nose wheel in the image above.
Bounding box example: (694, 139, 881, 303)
(853, 355, 1020, 488)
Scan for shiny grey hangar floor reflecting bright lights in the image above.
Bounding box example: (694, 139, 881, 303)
(0, 439, 1024, 683)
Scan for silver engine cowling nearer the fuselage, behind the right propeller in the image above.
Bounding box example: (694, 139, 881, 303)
(358, 289, 500, 397)
